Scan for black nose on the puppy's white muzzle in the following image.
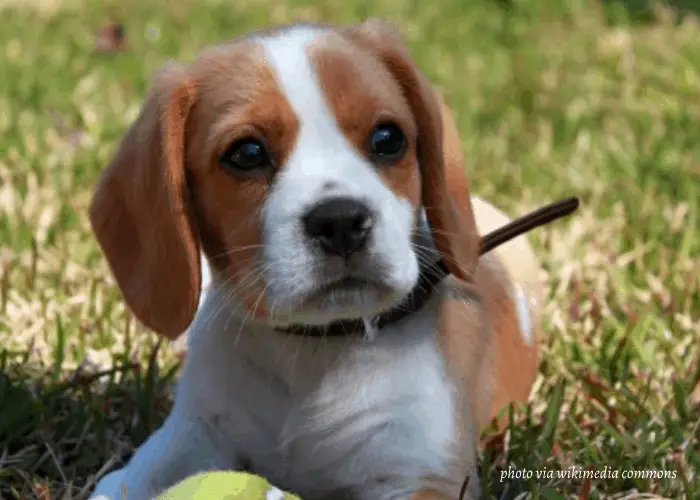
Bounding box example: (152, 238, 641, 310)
(304, 198, 372, 258)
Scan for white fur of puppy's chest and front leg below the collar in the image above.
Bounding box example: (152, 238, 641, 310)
(95, 274, 467, 500)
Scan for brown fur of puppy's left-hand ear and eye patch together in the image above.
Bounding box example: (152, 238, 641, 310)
(90, 38, 298, 338)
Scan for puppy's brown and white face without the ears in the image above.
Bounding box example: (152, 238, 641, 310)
(188, 26, 420, 324)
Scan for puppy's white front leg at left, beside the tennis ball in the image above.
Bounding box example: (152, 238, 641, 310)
(91, 412, 238, 500)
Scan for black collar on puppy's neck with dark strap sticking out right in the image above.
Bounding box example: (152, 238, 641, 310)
(278, 198, 579, 337)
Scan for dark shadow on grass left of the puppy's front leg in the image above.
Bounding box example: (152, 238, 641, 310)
(0, 353, 175, 500)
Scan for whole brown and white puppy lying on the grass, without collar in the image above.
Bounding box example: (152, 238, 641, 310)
(90, 20, 540, 500)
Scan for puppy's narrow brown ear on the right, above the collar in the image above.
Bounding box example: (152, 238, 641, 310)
(341, 19, 479, 281)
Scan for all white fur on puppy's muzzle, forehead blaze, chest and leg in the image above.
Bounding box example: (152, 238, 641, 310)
(93, 29, 477, 500)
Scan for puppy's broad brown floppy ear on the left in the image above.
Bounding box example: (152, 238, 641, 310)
(90, 63, 201, 338)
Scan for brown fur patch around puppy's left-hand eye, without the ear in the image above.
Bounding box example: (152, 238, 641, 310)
(188, 42, 299, 316)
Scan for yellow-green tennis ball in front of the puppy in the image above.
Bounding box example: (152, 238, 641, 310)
(158, 471, 301, 500)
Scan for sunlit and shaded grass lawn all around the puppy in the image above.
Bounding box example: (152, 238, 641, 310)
(0, 0, 700, 499)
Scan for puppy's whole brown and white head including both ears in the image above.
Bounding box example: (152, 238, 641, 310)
(90, 20, 478, 338)
